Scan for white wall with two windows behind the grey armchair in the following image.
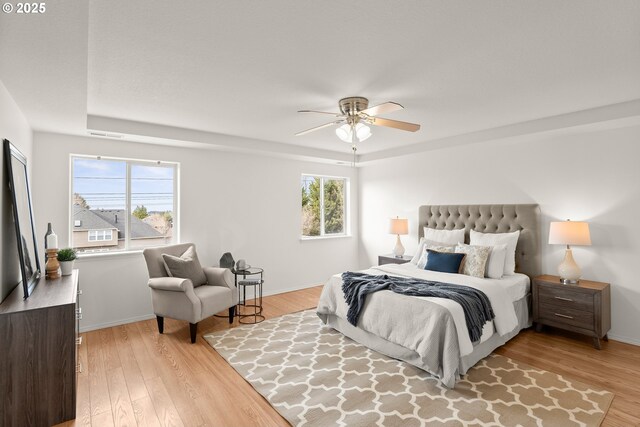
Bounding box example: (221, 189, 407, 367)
(33, 132, 358, 330)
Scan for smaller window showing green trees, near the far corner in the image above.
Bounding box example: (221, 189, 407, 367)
(302, 175, 348, 237)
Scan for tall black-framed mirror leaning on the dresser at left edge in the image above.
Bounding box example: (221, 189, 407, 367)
(0, 139, 41, 301)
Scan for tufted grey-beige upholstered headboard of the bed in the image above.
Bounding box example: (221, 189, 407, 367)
(418, 205, 542, 277)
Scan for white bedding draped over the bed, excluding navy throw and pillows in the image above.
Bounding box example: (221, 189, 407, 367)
(318, 263, 529, 387)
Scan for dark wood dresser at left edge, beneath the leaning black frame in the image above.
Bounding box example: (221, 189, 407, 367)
(0, 270, 80, 426)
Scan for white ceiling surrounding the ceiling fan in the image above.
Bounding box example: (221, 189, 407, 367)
(0, 0, 640, 159)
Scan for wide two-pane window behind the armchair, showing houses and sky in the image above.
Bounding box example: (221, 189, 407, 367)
(70, 156, 178, 252)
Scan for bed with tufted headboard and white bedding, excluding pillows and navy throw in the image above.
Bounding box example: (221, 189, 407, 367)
(317, 204, 541, 388)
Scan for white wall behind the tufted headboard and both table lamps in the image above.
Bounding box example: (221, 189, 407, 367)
(359, 126, 640, 344)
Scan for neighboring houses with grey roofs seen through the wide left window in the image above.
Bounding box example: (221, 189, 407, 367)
(72, 205, 171, 249)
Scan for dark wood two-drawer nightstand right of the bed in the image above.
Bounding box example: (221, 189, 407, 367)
(533, 276, 611, 350)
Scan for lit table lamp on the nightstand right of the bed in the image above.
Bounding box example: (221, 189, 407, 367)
(549, 220, 591, 285)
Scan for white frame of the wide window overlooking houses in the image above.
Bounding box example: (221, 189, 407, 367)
(68, 153, 180, 257)
